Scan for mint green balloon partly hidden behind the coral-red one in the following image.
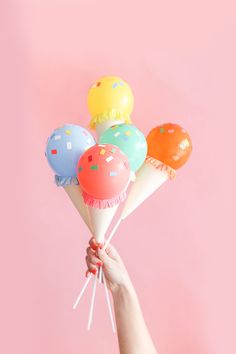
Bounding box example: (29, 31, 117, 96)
(99, 124, 147, 172)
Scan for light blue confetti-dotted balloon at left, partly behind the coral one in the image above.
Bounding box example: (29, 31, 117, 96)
(45, 124, 96, 183)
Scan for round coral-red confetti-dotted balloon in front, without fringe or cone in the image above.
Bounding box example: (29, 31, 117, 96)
(78, 144, 130, 199)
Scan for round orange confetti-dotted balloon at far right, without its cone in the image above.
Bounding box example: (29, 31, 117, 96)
(147, 123, 192, 170)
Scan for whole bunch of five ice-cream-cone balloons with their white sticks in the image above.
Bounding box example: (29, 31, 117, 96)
(45, 76, 192, 332)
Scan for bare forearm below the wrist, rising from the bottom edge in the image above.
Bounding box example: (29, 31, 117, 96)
(113, 282, 157, 354)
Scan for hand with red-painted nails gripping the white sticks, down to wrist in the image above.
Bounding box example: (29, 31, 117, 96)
(86, 237, 131, 293)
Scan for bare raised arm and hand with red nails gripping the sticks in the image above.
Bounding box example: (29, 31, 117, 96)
(86, 238, 157, 354)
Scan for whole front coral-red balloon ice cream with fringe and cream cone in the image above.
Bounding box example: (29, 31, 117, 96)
(78, 144, 130, 242)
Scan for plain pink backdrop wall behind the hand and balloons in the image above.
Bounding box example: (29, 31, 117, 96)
(0, 0, 236, 354)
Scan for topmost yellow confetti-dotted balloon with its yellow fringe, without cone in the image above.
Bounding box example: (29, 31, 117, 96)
(88, 76, 134, 129)
